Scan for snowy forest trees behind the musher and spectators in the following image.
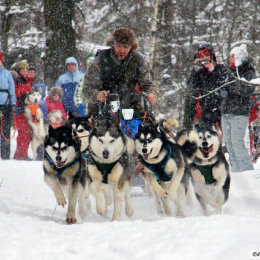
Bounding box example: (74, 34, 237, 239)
(0, 0, 260, 125)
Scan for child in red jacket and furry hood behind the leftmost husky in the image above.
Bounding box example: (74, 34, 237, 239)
(45, 87, 67, 127)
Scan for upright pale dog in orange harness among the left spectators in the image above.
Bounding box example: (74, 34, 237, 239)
(24, 88, 46, 160)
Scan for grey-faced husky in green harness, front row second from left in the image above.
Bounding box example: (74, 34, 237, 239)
(88, 119, 134, 220)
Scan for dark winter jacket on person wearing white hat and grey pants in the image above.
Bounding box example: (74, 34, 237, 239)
(221, 58, 256, 116)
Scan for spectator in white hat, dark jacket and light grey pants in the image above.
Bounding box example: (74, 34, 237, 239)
(221, 44, 256, 172)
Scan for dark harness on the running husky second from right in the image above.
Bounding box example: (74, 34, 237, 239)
(140, 145, 172, 182)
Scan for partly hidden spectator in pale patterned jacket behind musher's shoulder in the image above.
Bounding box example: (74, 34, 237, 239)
(74, 56, 94, 116)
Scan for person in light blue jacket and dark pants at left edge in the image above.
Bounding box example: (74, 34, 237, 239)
(0, 52, 16, 160)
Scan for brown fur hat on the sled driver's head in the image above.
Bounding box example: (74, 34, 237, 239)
(106, 27, 139, 50)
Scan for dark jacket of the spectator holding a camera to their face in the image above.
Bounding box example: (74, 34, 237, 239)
(184, 64, 227, 127)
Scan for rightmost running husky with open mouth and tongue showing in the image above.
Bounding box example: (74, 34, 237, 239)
(178, 125, 230, 215)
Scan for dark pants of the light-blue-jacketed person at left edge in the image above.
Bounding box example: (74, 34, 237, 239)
(0, 105, 12, 160)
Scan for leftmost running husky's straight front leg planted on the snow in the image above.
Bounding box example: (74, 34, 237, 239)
(66, 182, 79, 224)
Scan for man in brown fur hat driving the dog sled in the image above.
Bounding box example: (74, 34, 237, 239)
(83, 27, 158, 117)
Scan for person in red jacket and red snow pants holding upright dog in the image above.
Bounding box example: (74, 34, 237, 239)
(14, 61, 32, 160)
